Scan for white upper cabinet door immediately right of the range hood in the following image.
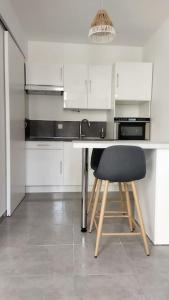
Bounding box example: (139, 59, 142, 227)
(64, 65, 88, 109)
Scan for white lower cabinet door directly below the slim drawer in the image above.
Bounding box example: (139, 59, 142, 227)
(26, 149, 63, 186)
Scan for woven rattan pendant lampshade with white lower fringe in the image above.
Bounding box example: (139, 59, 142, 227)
(89, 9, 116, 44)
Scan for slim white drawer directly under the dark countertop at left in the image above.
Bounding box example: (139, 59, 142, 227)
(26, 141, 64, 150)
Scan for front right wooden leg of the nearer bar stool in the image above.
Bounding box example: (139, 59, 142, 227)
(131, 181, 150, 255)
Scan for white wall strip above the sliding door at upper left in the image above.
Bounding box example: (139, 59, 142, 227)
(0, 0, 27, 55)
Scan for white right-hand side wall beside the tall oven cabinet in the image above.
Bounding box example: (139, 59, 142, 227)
(143, 19, 169, 142)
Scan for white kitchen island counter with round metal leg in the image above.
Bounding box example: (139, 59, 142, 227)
(73, 140, 169, 245)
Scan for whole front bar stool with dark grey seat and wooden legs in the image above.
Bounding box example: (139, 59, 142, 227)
(90, 146, 150, 257)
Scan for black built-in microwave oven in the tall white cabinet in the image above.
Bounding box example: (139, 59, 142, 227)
(114, 118, 150, 140)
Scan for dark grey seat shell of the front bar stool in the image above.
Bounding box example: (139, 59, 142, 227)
(94, 146, 146, 182)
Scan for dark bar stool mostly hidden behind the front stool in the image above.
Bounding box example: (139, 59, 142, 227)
(87, 148, 104, 214)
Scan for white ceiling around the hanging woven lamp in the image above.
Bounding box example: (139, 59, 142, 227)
(11, 0, 169, 46)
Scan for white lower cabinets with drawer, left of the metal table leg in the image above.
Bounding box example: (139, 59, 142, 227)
(26, 141, 82, 192)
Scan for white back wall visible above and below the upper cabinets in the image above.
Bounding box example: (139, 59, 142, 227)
(27, 41, 142, 121)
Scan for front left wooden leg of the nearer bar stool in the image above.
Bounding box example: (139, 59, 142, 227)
(94, 180, 109, 257)
